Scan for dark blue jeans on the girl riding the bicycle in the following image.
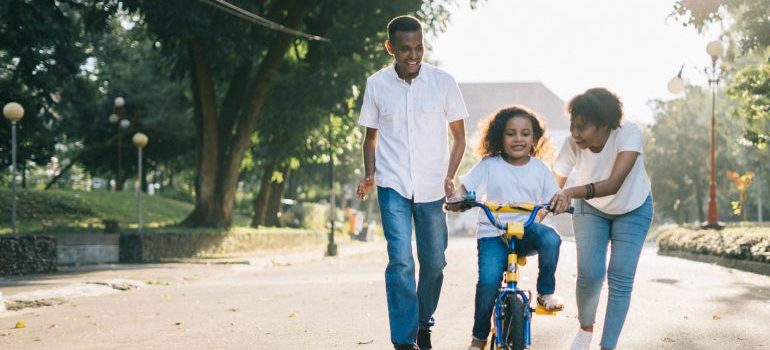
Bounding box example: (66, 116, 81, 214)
(473, 223, 561, 339)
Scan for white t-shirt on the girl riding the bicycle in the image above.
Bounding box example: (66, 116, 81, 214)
(460, 155, 559, 238)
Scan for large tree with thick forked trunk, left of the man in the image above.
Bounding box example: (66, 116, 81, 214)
(125, 0, 452, 226)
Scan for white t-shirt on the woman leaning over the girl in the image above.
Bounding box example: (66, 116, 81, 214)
(553, 122, 651, 215)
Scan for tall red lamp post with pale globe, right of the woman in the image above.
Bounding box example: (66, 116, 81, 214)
(703, 40, 724, 229)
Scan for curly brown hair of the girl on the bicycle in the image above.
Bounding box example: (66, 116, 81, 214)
(477, 105, 553, 163)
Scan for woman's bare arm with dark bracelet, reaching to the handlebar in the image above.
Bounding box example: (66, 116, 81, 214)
(551, 151, 639, 214)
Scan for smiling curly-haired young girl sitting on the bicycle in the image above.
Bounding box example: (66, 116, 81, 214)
(447, 106, 564, 350)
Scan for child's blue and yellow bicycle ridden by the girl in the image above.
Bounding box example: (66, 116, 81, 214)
(444, 190, 574, 350)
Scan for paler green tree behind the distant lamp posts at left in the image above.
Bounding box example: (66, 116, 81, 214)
(62, 14, 194, 180)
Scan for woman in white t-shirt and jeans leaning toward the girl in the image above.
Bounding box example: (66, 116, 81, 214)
(551, 88, 652, 350)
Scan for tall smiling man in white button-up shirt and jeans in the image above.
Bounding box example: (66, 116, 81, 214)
(357, 16, 468, 350)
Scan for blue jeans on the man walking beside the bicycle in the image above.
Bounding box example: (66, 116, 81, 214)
(377, 187, 447, 345)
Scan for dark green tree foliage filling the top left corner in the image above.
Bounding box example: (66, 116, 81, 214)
(0, 0, 116, 170)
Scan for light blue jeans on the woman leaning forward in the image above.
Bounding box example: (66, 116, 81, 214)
(572, 196, 653, 349)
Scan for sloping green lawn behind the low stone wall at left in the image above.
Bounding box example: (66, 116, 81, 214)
(0, 189, 192, 234)
